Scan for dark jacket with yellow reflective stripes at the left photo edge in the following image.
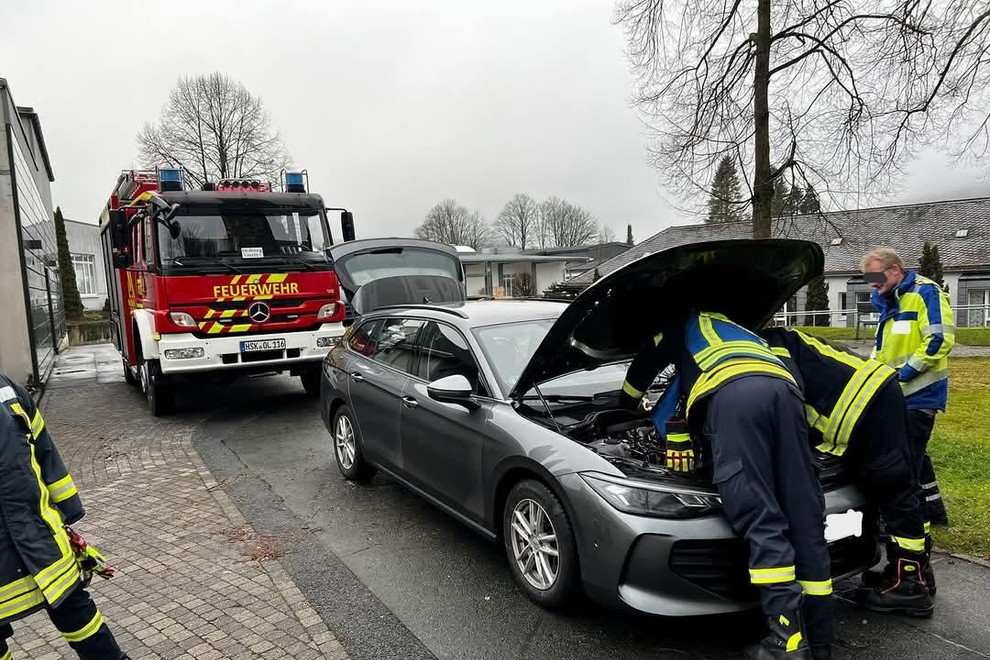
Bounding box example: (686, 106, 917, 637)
(0, 375, 84, 625)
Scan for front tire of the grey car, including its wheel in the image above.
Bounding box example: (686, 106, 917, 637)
(502, 479, 581, 609)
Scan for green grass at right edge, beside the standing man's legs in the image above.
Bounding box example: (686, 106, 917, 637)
(928, 357, 990, 559)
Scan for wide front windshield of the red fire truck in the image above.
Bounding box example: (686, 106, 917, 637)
(158, 209, 330, 265)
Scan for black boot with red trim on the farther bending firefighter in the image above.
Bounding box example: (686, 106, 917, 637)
(856, 545, 935, 617)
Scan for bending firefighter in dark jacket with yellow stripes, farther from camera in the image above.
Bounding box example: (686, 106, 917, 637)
(761, 328, 935, 616)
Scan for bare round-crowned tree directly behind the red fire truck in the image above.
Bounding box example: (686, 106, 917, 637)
(137, 73, 292, 186)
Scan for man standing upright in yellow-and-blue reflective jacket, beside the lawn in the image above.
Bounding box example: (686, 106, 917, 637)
(860, 248, 956, 525)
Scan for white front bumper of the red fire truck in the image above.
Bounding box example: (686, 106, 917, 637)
(158, 323, 344, 374)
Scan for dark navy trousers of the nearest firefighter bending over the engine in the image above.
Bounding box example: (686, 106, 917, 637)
(704, 375, 834, 632)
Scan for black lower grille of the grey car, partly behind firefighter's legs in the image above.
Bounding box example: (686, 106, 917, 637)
(670, 515, 879, 601)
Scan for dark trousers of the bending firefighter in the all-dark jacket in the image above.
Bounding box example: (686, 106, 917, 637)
(842, 380, 926, 539)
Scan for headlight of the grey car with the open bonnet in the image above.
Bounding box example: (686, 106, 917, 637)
(581, 472, 722, 518)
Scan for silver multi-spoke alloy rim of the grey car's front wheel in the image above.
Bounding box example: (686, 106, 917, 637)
(509, 499, 560, 590)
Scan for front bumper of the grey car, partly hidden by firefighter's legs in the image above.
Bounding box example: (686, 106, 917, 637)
(558, 474, 878, 616)
